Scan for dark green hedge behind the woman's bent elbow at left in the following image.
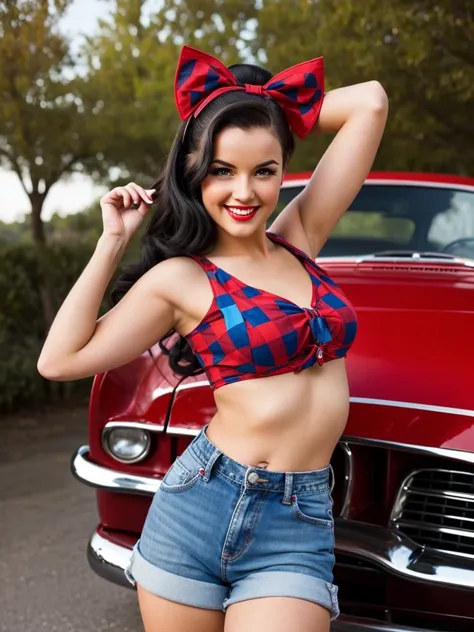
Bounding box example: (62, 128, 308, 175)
(0, 203, 144, 414)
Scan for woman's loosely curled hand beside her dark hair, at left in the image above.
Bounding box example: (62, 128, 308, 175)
(100, 182, 155, 244)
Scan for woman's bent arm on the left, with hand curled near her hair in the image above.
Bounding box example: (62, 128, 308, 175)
(38, 184, 176, 381)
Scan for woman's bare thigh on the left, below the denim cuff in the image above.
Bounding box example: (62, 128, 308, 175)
(137, 586, 225, 632)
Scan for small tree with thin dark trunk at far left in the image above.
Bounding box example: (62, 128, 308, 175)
(0, 0, 100, 324)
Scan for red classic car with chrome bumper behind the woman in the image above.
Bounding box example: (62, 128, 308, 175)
(72, 173, 474, 632)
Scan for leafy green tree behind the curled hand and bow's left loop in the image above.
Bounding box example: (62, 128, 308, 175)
(80, 0, 256, 184)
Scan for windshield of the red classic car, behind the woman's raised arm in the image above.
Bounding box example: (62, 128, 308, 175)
(271, 183, 474, 259)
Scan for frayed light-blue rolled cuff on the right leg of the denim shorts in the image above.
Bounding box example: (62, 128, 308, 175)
(224, 571, 339, 621)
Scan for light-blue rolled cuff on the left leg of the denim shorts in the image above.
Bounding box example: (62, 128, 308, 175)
(125, 546, 229, 610)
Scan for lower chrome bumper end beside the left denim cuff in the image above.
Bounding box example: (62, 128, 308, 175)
(87, 532, 132, 588)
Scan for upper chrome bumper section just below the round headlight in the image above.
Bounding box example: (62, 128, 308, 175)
(71, 445, 161, 496)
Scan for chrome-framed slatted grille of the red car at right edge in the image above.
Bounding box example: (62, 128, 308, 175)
(390, 469, 474, 557)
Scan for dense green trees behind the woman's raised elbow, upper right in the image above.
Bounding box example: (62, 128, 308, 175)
(251, 0, 474, 174)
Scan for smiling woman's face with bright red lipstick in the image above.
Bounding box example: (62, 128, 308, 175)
(201, 127, 283, 237)
